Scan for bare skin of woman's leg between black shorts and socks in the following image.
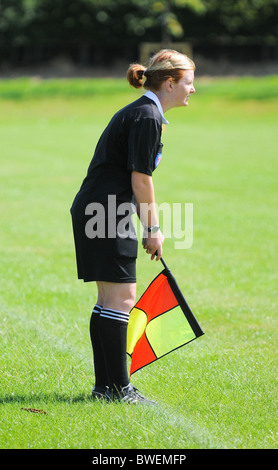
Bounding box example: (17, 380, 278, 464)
(97, 281, 136, 312)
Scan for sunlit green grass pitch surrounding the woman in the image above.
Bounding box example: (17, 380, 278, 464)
(0, 77, 278, 449)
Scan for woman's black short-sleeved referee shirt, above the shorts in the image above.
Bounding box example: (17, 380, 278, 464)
(75, 96, 162, 203)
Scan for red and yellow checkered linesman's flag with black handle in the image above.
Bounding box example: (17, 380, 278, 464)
(127, 258, 204, 375)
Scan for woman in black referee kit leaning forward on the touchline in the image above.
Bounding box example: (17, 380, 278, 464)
(71, 50, 195, 403)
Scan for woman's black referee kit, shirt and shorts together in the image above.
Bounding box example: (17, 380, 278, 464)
(71, 96, 162, 282)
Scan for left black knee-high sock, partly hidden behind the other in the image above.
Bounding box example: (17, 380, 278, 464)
(90, 304, 109, 388)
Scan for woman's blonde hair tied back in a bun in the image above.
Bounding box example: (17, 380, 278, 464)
(127, 49, 196, 91)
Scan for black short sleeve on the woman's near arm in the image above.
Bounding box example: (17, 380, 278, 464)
(127, 118, 161, 176)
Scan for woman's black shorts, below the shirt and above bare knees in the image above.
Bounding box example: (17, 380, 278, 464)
(71, 198, 138, 283)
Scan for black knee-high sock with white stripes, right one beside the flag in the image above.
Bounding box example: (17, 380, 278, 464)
(99, 308, 129, 391)
